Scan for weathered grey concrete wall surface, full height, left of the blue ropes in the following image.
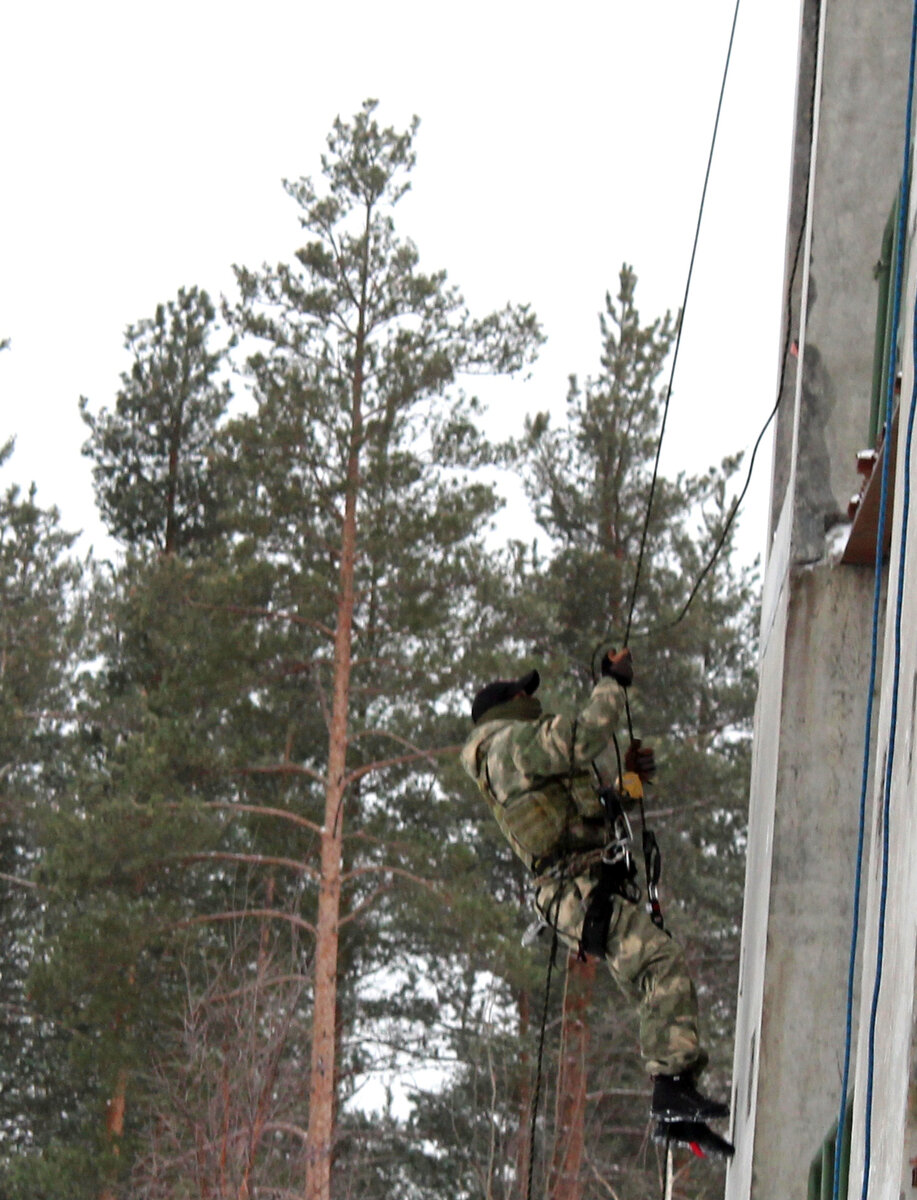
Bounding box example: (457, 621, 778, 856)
(726, 0, 917, 1200)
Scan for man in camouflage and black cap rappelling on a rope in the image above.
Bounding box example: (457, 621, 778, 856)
(462, 649, 733, 1156)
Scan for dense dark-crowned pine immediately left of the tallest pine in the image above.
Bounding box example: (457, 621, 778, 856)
(11, 288, 238, 1196)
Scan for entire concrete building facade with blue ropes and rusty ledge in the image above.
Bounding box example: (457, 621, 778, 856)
(726, 0, 917, 1200)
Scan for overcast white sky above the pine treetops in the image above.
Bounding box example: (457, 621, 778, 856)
(0, 0, 799, 571)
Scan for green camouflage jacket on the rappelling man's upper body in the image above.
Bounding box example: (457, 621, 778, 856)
(462, 679, 618, 868)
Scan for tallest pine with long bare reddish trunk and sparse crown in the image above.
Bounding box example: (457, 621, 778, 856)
(224, 102, 538, 1200)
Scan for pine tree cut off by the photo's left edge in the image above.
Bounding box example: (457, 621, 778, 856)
(0, 442, 80, 1162)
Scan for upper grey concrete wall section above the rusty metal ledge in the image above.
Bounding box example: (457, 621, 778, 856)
(793, 0, 911, 562)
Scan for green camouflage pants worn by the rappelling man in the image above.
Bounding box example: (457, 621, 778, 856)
(535, 876, 707, 1075)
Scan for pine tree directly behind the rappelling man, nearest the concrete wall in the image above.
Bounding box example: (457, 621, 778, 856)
(405, 266, 755, 1200)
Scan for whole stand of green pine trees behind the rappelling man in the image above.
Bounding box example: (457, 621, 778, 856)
(0, 114, 754, 1200)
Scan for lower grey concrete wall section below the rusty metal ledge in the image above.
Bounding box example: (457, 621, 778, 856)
(726, 563, 871, 1200)
